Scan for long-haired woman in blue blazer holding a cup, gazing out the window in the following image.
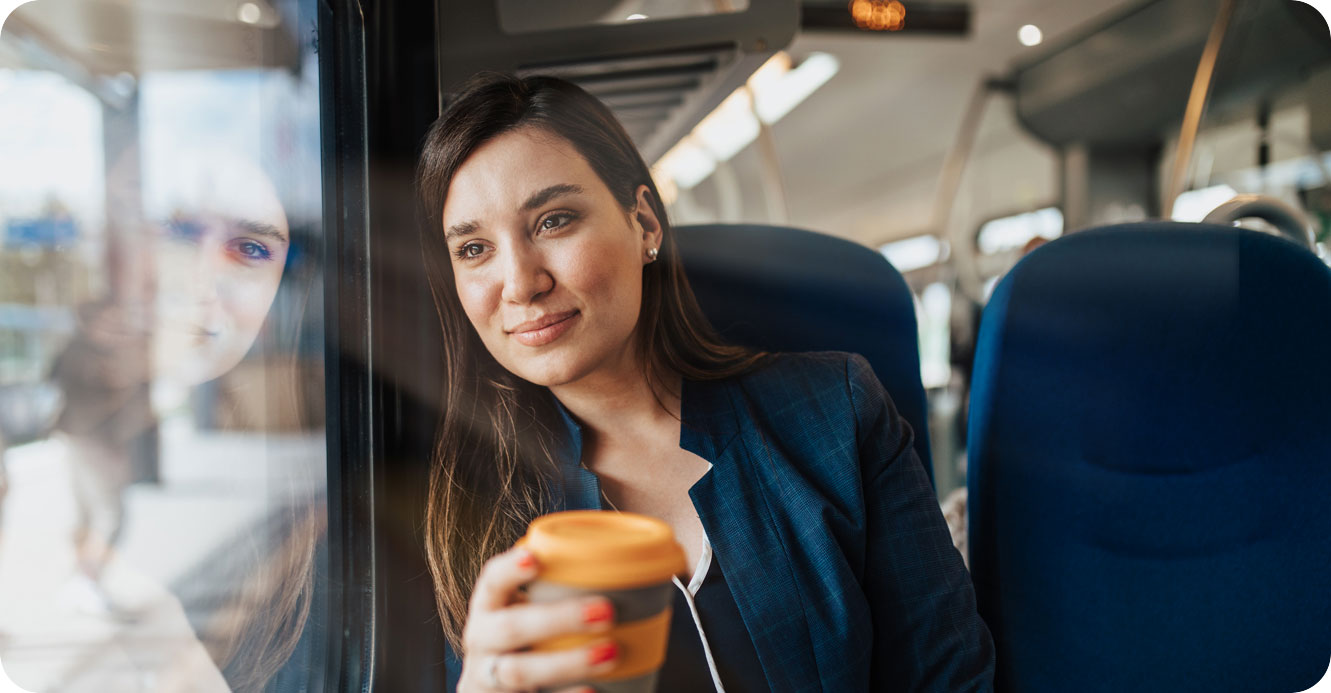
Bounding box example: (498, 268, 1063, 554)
(417, 74, 993, 692)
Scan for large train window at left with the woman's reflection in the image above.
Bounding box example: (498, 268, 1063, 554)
(0, 0, 329, 690)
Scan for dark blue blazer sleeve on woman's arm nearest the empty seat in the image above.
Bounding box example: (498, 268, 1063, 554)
(847, 355, 994, 693)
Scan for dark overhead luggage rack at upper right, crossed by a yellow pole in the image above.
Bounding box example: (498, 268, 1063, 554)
(1012, 0, 1331, 146)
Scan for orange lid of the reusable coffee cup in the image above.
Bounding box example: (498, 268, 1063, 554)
(518, 511, 687, 589)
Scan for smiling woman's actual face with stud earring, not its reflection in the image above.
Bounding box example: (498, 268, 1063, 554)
(443, 128, 662, 387)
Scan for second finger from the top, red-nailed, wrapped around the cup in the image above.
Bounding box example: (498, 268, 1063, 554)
(467, 596, 615, 652)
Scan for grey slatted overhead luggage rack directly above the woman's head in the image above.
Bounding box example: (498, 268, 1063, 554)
(439, 0, 799, 161)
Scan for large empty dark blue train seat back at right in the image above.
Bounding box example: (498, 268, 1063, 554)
(968, 222, 1331, 693)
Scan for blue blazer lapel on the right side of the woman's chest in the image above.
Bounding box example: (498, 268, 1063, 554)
(680, 380, 820, 690)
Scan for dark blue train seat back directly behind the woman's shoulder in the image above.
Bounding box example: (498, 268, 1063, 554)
(676, 225, 933, 480)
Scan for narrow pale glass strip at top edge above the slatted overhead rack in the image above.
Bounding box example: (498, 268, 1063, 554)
(495, 0, 748, 33)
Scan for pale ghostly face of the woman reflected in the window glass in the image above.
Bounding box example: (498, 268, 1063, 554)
(153, 157, 290, 384)
